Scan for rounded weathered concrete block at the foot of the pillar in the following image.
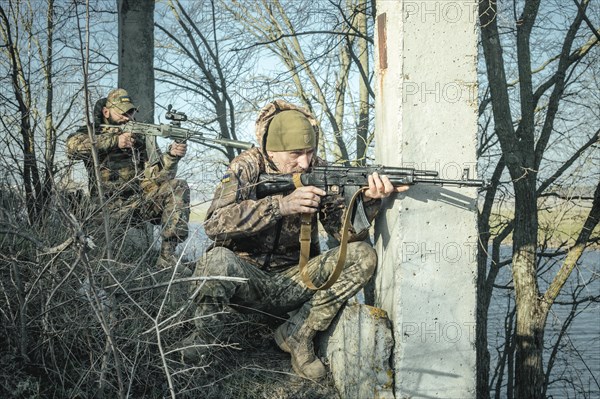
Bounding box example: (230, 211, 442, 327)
(318, 303, 394, 399)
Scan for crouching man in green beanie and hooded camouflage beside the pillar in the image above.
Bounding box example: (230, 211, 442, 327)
(183, 100, 407, 380)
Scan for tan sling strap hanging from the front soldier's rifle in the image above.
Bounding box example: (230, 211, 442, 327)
(293, 173, 368, 291)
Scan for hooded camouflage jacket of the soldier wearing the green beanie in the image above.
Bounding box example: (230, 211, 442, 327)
(204, 101, 381, 270)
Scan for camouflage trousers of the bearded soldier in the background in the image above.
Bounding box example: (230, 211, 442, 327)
(108, 179, 190, 243)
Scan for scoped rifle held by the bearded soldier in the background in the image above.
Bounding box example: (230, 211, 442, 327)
(100, 105, 254, 150)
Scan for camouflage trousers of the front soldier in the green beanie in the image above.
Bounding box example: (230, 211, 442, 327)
(194, 242, 377, 331)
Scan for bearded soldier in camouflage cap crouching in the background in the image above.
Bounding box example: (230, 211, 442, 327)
(67, 89, 190, 268)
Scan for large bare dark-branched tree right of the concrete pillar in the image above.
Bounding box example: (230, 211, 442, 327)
(477, 1, 600, 398)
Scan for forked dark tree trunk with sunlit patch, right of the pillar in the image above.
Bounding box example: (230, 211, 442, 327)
(480, 1, 547, 398)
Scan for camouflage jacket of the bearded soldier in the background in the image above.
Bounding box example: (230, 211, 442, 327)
(67, 125, 179, 197)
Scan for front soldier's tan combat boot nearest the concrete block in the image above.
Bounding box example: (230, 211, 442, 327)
(275, 306, 327, 380)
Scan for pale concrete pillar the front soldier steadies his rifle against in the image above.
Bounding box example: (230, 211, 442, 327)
(374, 0, 477, 398)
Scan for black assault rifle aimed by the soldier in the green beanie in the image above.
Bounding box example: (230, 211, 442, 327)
(256, 165, 487, 198)
